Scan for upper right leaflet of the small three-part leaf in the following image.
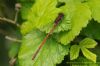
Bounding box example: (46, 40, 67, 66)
(79, 38, 97, 48)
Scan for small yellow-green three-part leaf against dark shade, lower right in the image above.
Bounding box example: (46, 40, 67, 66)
(70, 38, 97, 63)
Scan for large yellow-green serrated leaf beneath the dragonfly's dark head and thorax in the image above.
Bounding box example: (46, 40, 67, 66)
(21, 0, 76, 34)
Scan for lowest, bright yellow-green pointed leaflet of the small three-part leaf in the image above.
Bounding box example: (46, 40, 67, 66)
(81, 48, 97, 63)
